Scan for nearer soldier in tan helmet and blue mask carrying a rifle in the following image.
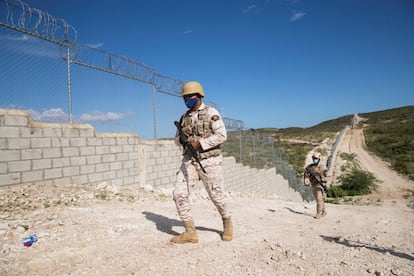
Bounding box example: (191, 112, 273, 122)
(171, 81, 233, 243)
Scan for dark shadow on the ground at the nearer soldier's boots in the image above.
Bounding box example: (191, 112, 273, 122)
(142, 211, 222, 236)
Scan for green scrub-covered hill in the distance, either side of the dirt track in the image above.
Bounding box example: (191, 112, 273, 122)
(223, 106, 414, 179)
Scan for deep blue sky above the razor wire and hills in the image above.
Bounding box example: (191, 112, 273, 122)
(0, 0, 414, 138)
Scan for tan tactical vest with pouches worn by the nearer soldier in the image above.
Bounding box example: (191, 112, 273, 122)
(180, 106, 221, 159)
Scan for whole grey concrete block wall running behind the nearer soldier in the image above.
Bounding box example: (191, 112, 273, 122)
(0, 109, 302, 201)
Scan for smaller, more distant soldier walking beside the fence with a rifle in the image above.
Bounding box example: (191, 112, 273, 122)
(303, 152, 327, 219)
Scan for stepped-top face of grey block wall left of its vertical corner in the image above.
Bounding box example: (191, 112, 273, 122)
(0, 109, 142, 189)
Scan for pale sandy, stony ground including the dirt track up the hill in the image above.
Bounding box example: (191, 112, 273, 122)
(0, 125, 414, 275)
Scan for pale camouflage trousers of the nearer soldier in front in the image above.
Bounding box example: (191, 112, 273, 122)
(173, 155, 231, 221)
